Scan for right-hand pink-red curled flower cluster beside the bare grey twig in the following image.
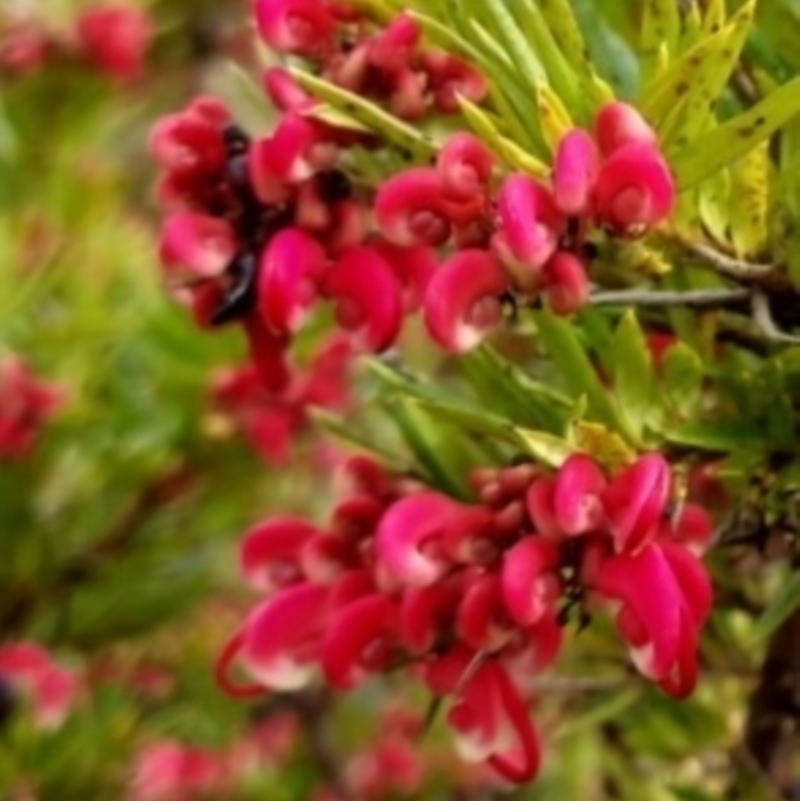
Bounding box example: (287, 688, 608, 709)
(382, 102, 675, 352)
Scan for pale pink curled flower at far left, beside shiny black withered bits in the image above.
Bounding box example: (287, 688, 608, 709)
(159, 211, 237, 278)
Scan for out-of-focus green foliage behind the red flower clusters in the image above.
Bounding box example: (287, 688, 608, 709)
(0, 0, 800, 801)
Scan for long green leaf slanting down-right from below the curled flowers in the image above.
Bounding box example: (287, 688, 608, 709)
(535, 311, 635, 439)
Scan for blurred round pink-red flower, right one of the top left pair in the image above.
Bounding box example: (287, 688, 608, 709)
(77, 2, 154, 81)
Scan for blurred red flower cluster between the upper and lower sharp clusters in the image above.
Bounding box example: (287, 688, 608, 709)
(211, 336, 352, 465)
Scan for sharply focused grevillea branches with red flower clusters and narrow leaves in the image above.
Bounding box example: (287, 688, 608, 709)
(141, 0, 800, 783)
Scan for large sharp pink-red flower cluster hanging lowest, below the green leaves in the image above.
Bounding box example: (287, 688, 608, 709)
(218, 453, 711, 782)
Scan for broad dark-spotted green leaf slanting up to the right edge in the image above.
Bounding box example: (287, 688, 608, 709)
(667, 77, 800, 191)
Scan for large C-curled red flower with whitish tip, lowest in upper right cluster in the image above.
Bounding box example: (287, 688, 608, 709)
(424, 249, 508, 353)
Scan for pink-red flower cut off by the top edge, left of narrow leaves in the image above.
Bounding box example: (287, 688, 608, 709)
(254, 0, 336, 56)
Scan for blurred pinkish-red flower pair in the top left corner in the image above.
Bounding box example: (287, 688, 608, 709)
(0, 2, 154, 82)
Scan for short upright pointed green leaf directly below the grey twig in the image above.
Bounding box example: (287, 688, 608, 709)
(613, 310, 656, 438)
